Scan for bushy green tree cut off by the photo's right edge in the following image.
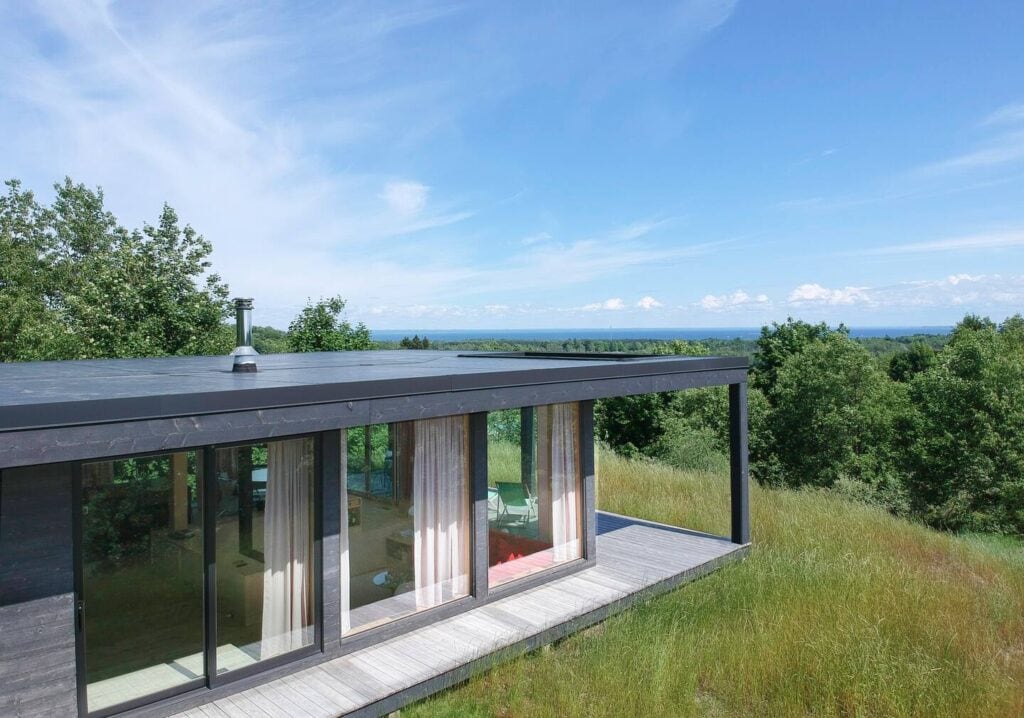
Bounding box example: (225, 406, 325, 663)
(907, 315, 1024, 534)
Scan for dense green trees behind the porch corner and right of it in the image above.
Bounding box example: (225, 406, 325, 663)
(596, 315, 1024, 534)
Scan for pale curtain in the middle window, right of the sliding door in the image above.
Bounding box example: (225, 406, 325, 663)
(413, 417, 470, 608)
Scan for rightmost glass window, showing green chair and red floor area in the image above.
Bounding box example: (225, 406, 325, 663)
(487, 404, 582, 586)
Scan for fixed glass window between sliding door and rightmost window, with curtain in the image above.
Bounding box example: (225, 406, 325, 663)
(341, 416, 471, 633)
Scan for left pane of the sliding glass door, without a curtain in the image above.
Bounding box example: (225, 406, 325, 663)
(80, 452, 204, 712)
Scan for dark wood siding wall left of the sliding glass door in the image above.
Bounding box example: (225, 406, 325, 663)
(0, 464, 78, 717)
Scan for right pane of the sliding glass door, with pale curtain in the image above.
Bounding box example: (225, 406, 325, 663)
(214, 437, 316, 674)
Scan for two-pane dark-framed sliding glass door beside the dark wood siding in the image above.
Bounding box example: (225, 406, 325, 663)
(75, 437, 319, 715)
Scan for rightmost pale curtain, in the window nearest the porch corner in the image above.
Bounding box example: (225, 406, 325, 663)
(537, 404, 580, 561)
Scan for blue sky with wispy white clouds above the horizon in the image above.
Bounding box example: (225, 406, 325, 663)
(0, 0, 1024, 329)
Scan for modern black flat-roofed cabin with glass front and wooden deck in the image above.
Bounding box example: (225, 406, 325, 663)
(0, 311, 750, 717)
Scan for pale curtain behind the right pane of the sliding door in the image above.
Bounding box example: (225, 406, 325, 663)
(260, 438, 313, 659)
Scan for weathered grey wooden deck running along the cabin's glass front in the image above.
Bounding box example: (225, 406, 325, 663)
(165, 512, 748, 718)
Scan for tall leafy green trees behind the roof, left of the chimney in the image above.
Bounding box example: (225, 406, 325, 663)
(0, 179, 231, 361)
